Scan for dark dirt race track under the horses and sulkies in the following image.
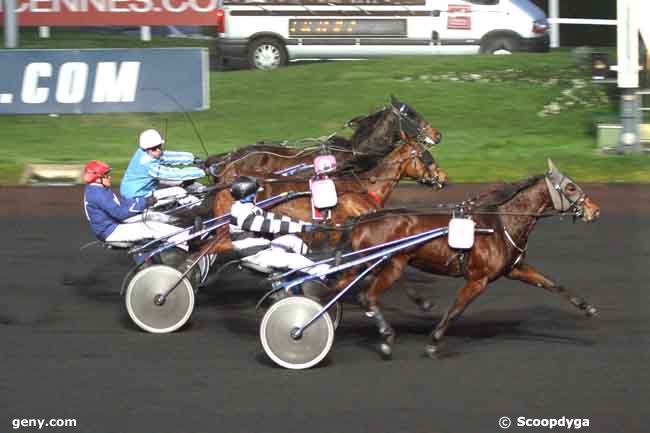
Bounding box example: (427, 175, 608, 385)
(0, 185, 650, 433)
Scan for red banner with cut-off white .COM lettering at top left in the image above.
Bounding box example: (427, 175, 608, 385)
(0, 0, 218, 27)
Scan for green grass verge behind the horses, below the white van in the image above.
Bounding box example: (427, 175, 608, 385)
(0, 29, 650, 184)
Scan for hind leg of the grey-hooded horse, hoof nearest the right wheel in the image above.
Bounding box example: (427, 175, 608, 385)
(366, 257, 408, 359)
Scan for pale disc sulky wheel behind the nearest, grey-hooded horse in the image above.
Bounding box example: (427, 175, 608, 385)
(260, 296, 334, 370)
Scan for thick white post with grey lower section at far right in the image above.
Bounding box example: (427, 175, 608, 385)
(616, 0, 646, 153)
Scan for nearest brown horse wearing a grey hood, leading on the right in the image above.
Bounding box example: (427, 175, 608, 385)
(337, 160, 600, 357)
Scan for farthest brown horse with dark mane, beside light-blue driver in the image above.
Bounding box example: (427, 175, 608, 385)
(206, 97, 442, 180)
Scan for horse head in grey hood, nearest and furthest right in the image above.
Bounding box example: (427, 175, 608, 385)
(545, 159, 600, 222)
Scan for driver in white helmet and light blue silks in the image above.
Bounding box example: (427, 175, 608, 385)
(120, 129, 205, 205)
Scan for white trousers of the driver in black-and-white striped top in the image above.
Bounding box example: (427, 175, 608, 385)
(244, 235, 330, 275)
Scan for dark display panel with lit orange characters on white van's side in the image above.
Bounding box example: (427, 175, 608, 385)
(289, 19, 406, 38)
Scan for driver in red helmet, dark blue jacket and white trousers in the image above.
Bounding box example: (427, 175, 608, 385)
(83, 160, 187, 249)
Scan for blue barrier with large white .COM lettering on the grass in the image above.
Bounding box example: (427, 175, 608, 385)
(0, 48, 210, 114)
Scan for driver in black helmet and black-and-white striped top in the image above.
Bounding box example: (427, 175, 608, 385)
(230, 176, 329, 274)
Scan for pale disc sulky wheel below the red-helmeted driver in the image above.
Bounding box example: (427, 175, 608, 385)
(125, 265, 194, 334)
